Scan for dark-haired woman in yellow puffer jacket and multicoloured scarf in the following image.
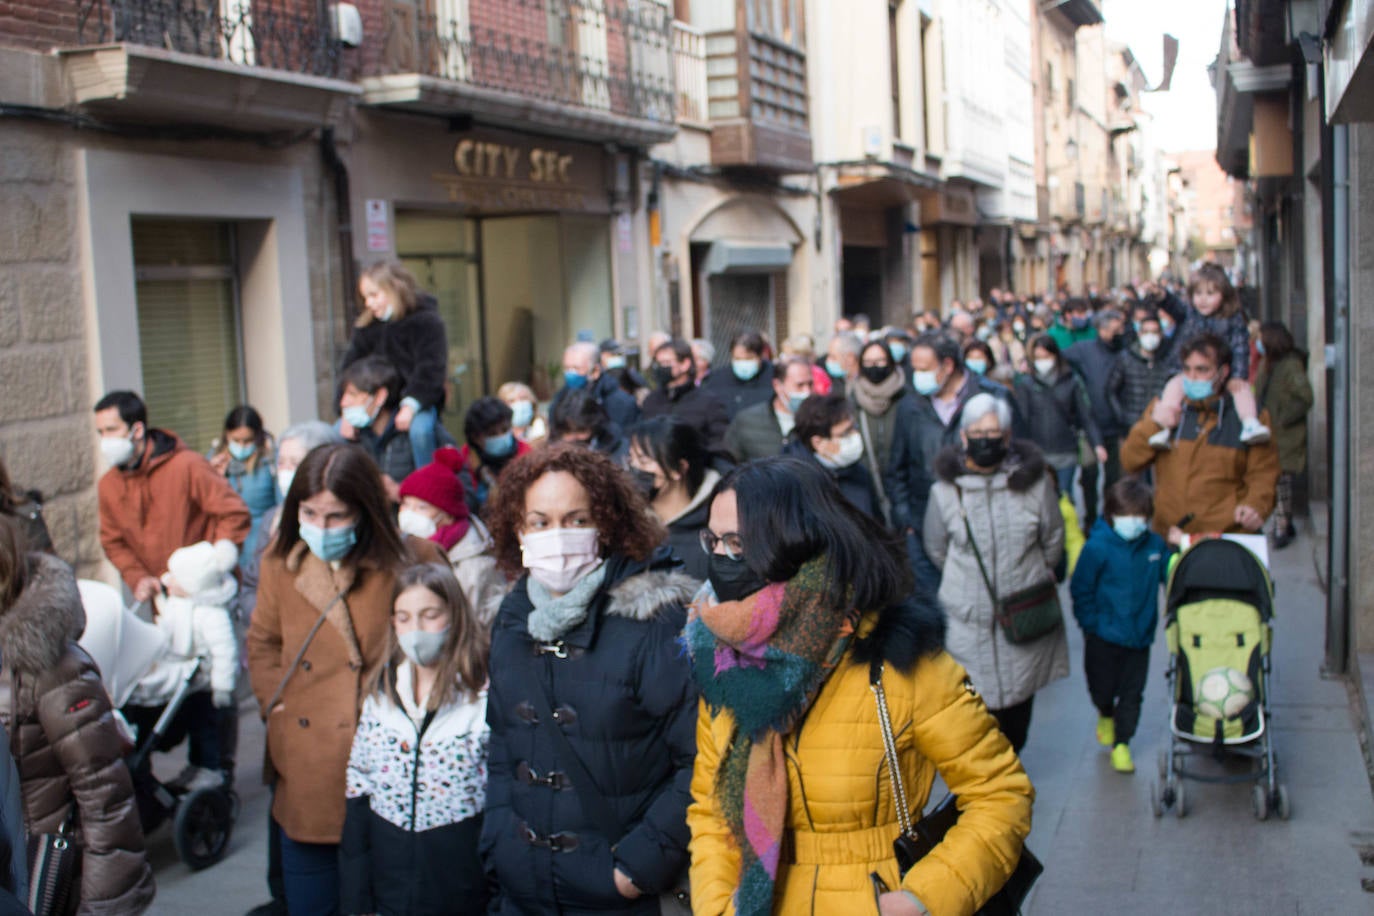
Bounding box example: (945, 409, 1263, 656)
(684, 457, 1035, 916)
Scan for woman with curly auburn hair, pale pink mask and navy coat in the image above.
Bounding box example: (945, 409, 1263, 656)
(481, 444, 697, 916)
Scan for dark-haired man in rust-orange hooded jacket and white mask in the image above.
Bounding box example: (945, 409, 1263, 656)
(95, 391, 251, 602)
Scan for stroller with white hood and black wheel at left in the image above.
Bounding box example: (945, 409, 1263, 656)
(77, 580, 239, 871)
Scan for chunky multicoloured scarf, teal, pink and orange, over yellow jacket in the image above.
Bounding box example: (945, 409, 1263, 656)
(683, 558, 859, 916)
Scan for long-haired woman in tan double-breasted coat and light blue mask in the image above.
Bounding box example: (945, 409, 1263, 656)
(247, 445, 444, 916)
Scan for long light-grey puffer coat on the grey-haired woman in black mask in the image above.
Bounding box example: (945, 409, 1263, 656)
(925, 439, 1069, 710)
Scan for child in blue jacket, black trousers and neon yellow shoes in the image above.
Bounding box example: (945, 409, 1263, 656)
(1069, 477, 1168, 773)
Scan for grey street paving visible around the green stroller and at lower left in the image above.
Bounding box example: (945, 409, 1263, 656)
(150, 519, 1374, 916)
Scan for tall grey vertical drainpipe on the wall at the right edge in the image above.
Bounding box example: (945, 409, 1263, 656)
(1325, 124, 1355, 674)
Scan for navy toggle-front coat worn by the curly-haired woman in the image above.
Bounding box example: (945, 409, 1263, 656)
(481, 548, 697, 916)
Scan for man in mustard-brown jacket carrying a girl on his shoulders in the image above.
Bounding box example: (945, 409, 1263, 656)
(1121, 334, 1279, 534)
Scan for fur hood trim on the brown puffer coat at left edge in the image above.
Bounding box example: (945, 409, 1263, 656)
(0, 553, 85, 674)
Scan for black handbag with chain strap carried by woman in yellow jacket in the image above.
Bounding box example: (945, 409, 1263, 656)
(868, 665, 1044, 916)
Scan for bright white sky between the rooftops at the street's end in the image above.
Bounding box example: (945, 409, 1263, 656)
(1102, 0, 1227, 152)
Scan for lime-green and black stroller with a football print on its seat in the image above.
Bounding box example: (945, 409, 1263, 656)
(1150, 538, 1290, 820)
